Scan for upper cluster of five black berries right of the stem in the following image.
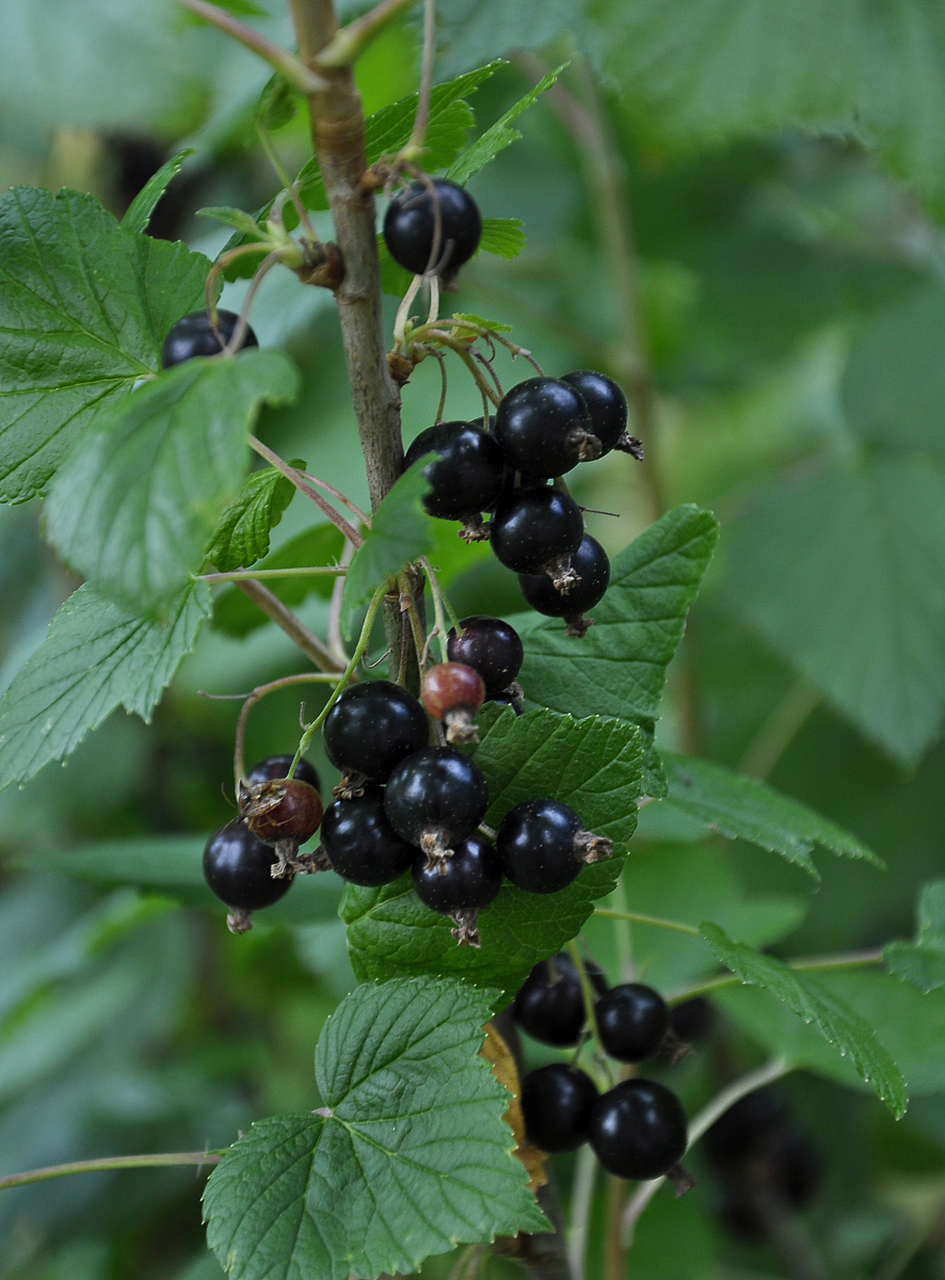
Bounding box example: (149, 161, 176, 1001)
(405, 370, 642, 635)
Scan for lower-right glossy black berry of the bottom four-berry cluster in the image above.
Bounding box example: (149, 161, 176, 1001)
(588, 1078, 688, 1179)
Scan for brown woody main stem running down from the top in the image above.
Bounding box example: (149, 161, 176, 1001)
(289, 0, 403, 671)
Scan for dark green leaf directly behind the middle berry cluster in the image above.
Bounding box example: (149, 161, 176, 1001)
(342, 708, 642, 995)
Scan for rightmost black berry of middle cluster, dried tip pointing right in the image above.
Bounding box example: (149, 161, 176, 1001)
(496, 800, 581, 893)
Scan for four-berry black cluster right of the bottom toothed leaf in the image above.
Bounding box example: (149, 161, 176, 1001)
(512, 952, 691, 1190)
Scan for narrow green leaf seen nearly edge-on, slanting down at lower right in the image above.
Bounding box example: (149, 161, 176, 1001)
(699, 922, 909, 1119)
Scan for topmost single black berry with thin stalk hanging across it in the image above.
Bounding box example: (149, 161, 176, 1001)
(384, 178, 483, 276)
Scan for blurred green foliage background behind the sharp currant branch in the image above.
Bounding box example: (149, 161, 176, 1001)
(0, 0, 945, 1280)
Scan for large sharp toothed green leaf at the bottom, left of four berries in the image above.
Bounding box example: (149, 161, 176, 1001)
(204, 978, 547, 1280)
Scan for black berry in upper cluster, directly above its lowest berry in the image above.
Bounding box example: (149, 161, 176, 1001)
(489, 485, 584, 581)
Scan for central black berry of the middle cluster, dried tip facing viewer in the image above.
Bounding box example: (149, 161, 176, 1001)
(384, 746, 489, 863)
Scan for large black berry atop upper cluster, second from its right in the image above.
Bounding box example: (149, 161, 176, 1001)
(496, 378, 602, 479)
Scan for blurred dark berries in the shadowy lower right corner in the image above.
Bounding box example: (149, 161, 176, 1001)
(703, 1089, 821, 1244)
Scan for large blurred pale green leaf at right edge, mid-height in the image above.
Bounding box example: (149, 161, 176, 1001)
(726, 456, 945, 763)
